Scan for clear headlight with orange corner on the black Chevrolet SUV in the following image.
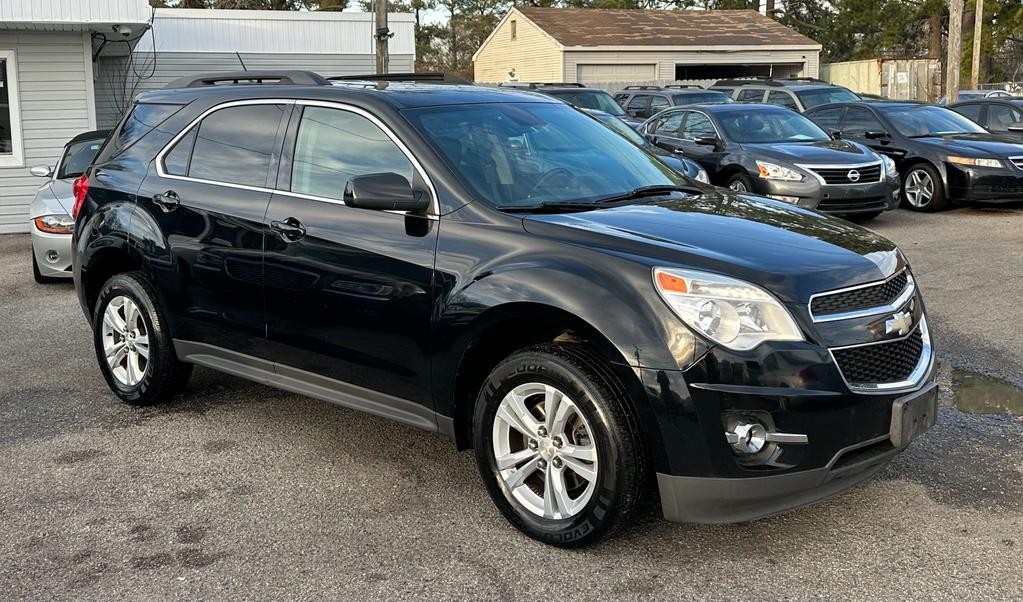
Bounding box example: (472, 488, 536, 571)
(654, 267, 803, 351)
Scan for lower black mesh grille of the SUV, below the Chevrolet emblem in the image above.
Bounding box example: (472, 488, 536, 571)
(832, 325, 924, 384)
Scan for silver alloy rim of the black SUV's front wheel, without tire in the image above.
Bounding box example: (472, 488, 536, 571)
(493, 383, 597, 519)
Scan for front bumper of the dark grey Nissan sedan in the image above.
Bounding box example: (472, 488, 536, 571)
(753, 176, 899, 214)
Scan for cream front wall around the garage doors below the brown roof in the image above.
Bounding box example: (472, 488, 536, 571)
(562, 48, 819, 82)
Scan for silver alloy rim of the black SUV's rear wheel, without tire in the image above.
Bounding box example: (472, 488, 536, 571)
(100, 295, 149, 387)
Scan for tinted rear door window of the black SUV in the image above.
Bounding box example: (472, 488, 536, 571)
(164, 104, 286, 187)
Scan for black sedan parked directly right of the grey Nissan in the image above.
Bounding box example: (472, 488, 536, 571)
(806, 101, 1023, 211)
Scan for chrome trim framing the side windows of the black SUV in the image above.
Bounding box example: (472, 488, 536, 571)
(154, 98, 440, 213)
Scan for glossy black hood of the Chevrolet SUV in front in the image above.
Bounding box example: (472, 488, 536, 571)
(523, 188, 899, 303)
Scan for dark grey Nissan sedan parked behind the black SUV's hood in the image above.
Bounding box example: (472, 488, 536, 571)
(641, 104, 898, 219)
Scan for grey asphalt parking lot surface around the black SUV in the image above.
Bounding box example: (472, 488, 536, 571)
(0, 207, 1023, 600)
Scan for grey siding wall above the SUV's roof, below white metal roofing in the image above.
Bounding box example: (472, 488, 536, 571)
(96, 52, 415, 127)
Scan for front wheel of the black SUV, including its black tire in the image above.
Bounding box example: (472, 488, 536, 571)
(473, 345, 648, 548)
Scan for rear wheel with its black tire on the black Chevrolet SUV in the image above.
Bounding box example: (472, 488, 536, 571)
(92, 272, 192, 405)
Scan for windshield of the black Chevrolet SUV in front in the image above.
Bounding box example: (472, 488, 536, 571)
(403, 102, 686, 207)
